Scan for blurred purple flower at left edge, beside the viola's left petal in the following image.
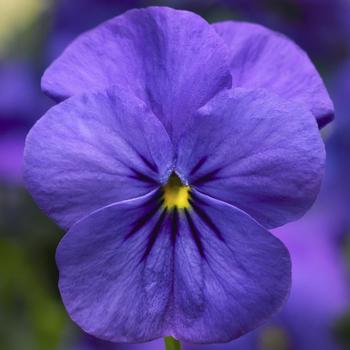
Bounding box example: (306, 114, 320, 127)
(0, 61, 50, 183)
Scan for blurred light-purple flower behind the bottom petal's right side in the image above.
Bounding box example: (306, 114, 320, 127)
(185, 207, 350, 350)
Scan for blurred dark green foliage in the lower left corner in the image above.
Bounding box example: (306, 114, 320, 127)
(0, 188, 70, 350)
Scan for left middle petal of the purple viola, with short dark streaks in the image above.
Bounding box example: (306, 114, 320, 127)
(24, 88, 173, 227)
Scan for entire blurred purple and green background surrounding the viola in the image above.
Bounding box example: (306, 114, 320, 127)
(0, 0, 350, 350)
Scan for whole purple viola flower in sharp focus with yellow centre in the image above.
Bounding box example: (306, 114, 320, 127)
(25, 7, 331, 343)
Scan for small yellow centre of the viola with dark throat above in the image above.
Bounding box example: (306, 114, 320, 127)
(163, 173, 190, 210)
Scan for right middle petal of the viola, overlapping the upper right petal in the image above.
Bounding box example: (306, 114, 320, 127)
(176, 88, 325, 227)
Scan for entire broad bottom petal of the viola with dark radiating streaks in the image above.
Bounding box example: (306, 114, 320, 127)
(56, 192, 290, 342)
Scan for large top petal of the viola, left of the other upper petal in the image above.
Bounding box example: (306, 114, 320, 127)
(42, 7, 231, 141)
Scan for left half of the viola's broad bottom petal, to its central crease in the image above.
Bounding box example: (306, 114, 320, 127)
(56, 192, 173, 342)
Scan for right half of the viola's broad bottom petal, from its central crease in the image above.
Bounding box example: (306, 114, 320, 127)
(173, 191, 291, 343)
